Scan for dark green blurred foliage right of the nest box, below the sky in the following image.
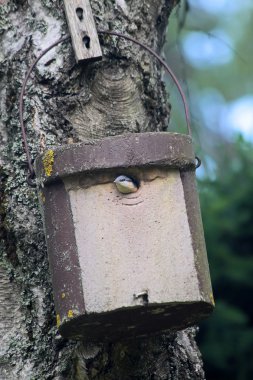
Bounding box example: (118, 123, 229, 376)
(199, 137, 253, 380)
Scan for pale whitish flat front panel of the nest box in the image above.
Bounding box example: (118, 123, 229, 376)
(64, 169, 201, 313)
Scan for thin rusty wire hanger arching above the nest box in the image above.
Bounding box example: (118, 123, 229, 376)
(19, 30, 193, 186)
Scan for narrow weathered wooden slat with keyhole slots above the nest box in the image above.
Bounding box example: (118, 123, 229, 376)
(64, 0, 102, 62)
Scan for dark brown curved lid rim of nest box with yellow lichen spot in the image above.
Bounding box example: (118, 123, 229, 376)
(35, 132, 195, 183)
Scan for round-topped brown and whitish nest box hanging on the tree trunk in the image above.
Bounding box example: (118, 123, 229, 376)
(36, 132, 214, 341)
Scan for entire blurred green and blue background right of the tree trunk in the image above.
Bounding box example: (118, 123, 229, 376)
(164, 0, 253, 380)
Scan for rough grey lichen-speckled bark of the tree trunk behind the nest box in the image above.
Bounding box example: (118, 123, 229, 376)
(0, 0, 204, 380)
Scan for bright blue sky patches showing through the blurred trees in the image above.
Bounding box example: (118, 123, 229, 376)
(181, 0, 253, 142)
